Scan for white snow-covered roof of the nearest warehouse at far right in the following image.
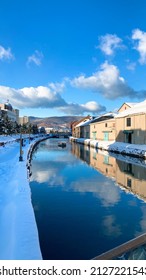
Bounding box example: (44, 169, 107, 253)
(116, 100, 146, 118)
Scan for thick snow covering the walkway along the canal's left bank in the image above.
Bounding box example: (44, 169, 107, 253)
(0, 136, 42, 260)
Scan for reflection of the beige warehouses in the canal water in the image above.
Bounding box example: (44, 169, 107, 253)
(71, 143, 146, 201)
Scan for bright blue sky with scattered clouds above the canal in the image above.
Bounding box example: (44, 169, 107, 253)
(0, 0, 146, 117)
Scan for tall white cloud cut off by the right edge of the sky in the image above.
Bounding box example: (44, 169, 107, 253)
(132, 29, 146, 64)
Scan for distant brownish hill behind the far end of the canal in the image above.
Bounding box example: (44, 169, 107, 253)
(30, 116, 82, 128)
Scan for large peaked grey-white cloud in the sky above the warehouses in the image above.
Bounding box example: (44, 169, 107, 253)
(70, 62, 135, 99)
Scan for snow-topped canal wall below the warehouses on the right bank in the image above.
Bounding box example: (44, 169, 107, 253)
(70, 137, 146, 159)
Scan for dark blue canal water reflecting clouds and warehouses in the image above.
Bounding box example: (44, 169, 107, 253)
(30, 138, 146, 260)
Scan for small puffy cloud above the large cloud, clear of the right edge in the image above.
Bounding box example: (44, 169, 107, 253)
(97, 34, 123, 55)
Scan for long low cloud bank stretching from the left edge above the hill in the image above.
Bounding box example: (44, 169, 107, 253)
(0, 83, 106, 115)
